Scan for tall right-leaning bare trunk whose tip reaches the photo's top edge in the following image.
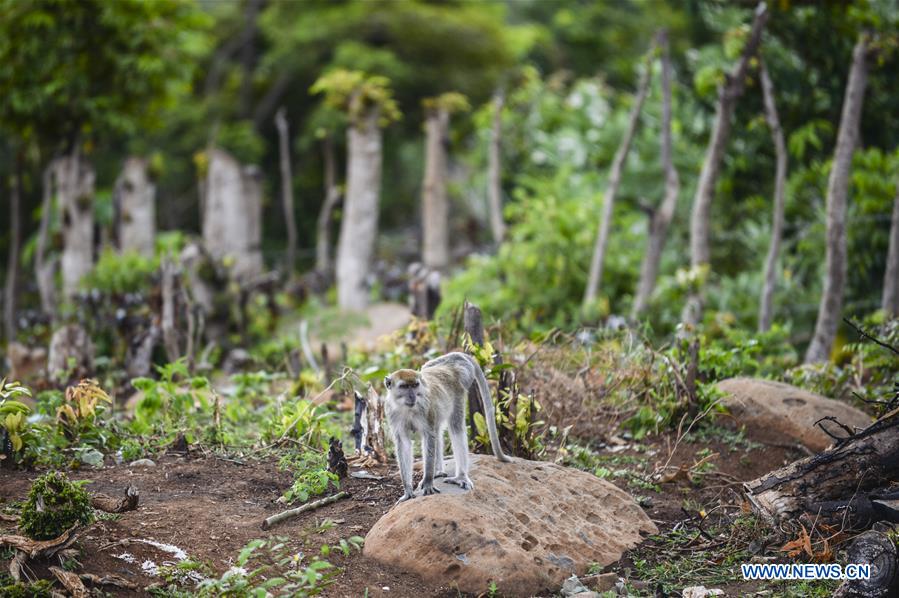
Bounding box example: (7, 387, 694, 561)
(681, 2, 768, 325)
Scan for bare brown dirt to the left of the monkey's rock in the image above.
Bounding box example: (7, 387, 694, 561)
(0, 456, 457, 597)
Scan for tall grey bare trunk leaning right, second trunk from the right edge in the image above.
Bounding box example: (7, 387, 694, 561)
(805, 33, 868, 363)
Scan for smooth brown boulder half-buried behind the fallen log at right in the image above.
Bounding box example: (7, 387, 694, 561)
(718, 378, 872, 452)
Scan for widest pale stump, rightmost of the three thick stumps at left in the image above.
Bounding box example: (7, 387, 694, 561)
(203, 149, 263, 279)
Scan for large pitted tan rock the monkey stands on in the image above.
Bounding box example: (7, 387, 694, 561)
(365, 456, 657, 596)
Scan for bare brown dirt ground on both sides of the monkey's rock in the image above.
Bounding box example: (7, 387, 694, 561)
(0, 420, 801, 597)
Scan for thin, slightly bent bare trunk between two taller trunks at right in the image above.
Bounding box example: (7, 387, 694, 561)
(759, 60, 787, 332)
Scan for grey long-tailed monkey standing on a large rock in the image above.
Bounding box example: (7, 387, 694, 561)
(384, 352, 511, 503)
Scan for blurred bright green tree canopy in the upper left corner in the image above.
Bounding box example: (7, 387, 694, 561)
(0, 0, 207, 142)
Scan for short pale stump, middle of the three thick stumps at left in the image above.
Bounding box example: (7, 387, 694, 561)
(115, 158, 156, 257)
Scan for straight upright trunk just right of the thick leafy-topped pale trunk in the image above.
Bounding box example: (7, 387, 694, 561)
(422, 108, 449, 270)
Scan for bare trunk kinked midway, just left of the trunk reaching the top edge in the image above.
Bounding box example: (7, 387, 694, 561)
(631, 31, 680, 318)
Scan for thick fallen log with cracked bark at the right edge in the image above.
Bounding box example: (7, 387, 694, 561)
(743, 410, 899, 528)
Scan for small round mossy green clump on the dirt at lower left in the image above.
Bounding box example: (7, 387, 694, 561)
(19, 471, 94, 540)
